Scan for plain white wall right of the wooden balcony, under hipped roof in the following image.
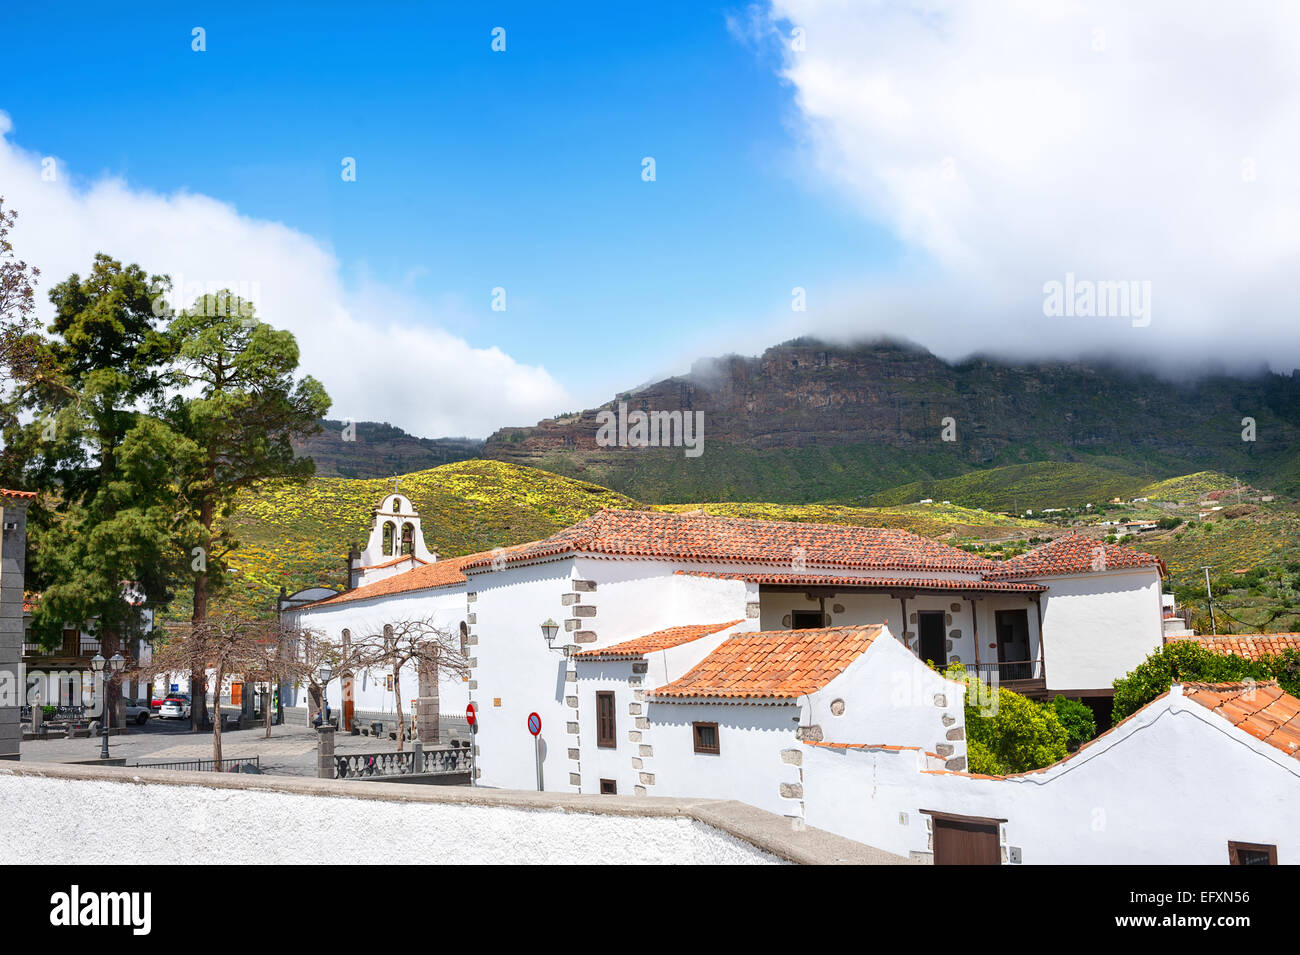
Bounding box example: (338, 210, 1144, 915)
(1040, 567, 1164, 691)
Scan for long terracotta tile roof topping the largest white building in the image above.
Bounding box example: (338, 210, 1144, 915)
(467, 511, 997, 573)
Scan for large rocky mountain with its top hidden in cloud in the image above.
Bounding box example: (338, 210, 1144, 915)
(482, 339, 1300, 503)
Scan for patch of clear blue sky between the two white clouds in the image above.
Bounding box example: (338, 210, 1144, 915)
(0, 3, 896, 411)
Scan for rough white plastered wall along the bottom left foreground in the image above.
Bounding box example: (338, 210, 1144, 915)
(0, 773, 779, 865)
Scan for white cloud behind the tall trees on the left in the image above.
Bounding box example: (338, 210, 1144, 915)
(0, 112, 572, 437)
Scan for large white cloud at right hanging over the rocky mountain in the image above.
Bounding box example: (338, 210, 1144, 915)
(759, 0, 1300, 370)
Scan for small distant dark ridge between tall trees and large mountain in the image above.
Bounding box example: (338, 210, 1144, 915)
(294, 420, 484, 478)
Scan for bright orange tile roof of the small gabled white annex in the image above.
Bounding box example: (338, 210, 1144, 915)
(651, 624, 884, 700)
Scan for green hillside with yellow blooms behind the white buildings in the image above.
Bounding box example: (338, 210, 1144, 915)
(192, 460, 1300, 630)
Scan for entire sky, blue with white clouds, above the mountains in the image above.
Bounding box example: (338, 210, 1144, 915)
(0, 0, 1300, 435)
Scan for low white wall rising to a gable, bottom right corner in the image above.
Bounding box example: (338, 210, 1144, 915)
(803, 687, 1300, 865)
